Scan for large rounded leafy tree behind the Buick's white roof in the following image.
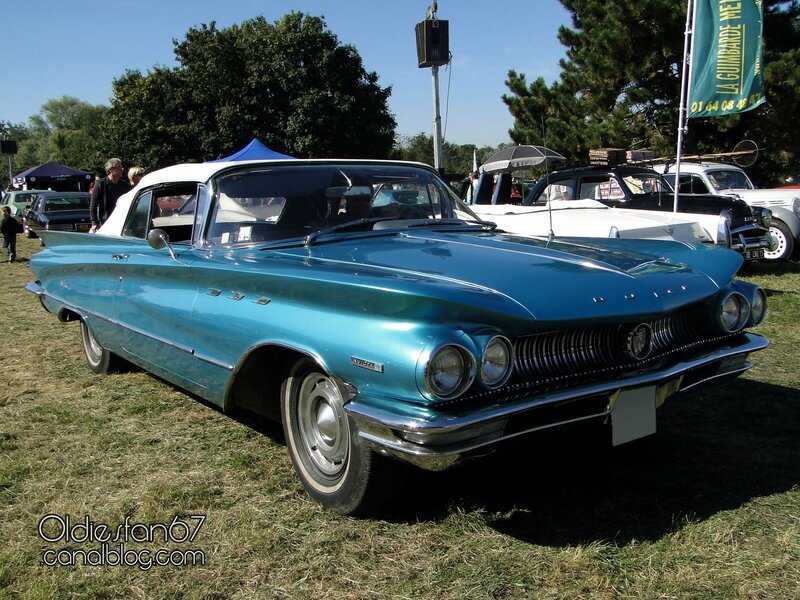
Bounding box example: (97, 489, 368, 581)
(103, 12, 396, 168)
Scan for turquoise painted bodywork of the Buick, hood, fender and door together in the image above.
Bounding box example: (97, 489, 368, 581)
(35, 230, 741, 405)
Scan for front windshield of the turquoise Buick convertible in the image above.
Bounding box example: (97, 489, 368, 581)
(206, 163, 479, 245)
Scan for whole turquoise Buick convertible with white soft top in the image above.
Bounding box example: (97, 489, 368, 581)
(27, 160, 767, 514)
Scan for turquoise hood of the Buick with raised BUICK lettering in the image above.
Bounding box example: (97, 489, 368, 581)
(266, 231, 742, 320)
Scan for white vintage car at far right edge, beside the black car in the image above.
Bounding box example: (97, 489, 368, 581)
(653, 161, 800, 261)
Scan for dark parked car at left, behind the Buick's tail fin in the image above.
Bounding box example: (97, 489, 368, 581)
(22, 191, 91, 238)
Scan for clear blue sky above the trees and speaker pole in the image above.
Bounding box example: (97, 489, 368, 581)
(0, 0, 570, 146)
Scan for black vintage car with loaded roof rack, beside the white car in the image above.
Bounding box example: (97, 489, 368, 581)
(523, 165, 776, 260)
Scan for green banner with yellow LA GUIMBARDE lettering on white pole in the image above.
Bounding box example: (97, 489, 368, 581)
(688, 0, 765, 117)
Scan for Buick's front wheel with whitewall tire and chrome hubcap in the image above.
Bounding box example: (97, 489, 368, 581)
(281, 359, 393, 515)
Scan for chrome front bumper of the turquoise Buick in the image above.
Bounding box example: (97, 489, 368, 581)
(345, 333, 769, 471)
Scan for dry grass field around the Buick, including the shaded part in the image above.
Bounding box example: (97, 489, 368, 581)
(0, 237, 800, 600)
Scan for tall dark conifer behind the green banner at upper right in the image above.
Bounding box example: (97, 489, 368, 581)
(503, 0, 800, 182)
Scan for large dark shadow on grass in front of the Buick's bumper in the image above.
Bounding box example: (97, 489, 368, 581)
(383, 379, 800, 546)
